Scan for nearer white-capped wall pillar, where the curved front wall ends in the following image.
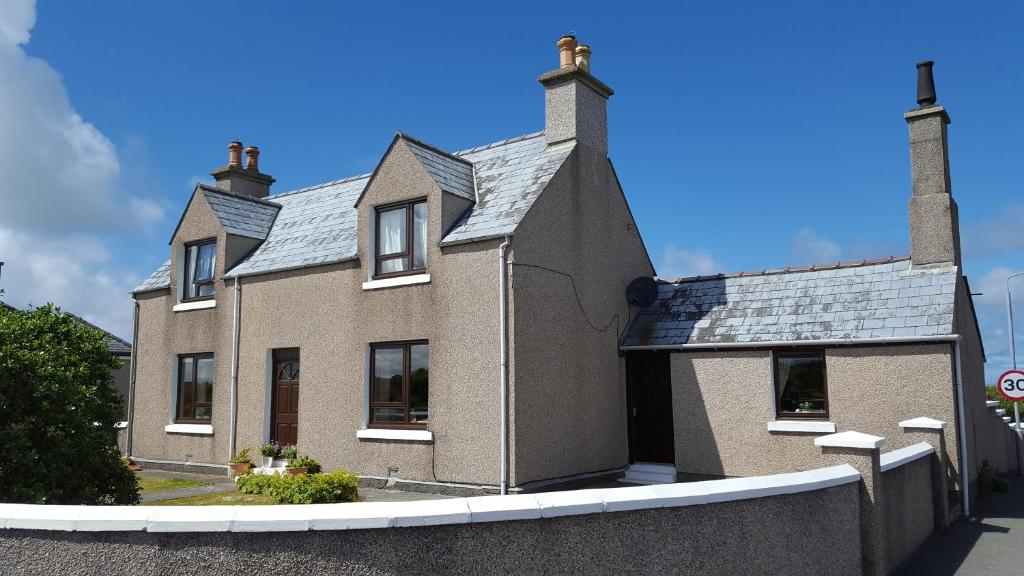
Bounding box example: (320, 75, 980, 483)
(814, 430, 888, 576)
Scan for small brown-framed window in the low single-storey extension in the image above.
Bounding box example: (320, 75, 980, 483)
(775, 352, 828, 418)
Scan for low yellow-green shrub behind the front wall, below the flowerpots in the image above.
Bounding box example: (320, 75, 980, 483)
(239, 470, 359, 504)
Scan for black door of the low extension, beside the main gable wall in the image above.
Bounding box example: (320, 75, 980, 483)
(626, 352, 676, 464)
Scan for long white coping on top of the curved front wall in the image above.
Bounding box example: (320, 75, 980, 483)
(0, 464, 860, 532)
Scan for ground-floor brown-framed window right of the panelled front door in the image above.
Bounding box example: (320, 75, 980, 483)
(370, 342, 430, 427)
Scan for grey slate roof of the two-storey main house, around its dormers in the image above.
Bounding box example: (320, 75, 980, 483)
(133, 132, 573, 292)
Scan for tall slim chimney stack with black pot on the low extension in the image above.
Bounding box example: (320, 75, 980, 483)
(903, 60, 961, 266)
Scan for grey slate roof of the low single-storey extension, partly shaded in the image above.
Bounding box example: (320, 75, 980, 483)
(623, 258, 956, 347)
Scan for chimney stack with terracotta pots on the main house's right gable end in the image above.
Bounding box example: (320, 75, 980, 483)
(539, 35, 613, 156)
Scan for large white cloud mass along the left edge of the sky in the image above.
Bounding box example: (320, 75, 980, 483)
(0, 0, 158, 337)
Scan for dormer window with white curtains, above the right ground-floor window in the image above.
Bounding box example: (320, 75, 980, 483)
(374, 200, 427, 278)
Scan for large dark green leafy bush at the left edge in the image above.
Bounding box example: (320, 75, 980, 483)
(0, 304, 138, 504)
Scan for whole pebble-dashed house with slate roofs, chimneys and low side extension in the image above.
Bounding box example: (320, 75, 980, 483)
(129, 37, 1010, 504)
